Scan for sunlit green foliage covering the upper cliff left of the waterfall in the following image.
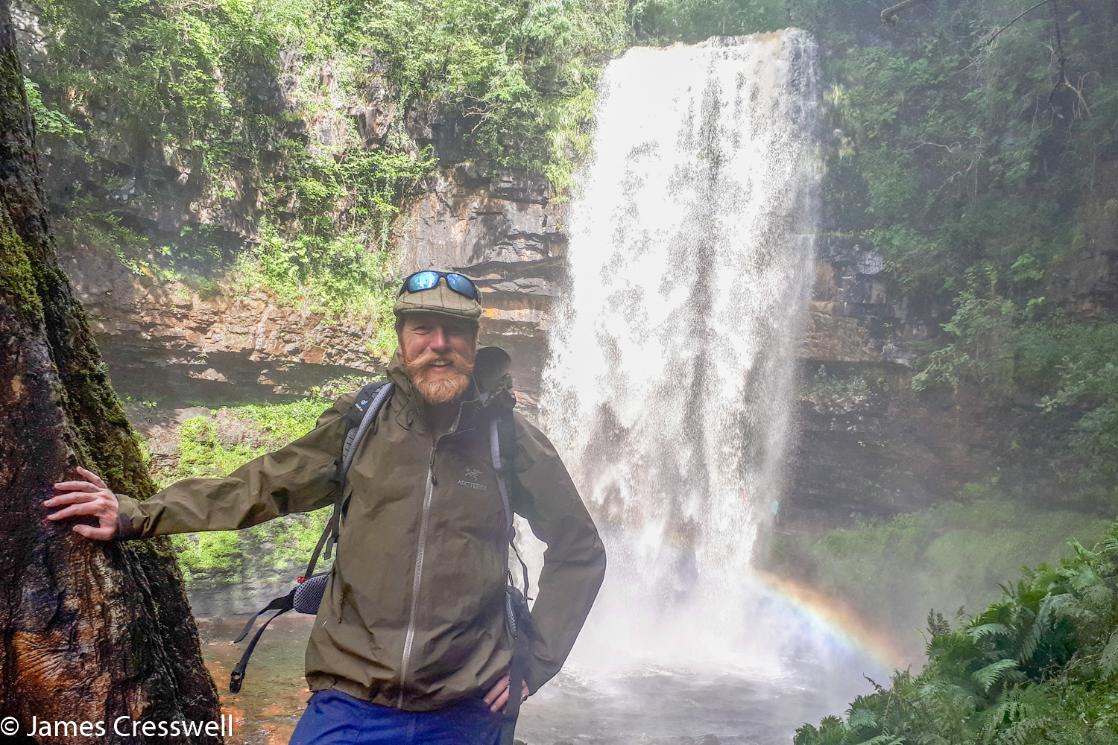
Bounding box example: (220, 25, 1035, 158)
(28, 0, 626, 335)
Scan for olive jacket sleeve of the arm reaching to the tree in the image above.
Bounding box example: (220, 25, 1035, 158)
(116, 395, 354, 540)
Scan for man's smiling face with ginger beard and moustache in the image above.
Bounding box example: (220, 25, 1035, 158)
(399, 313, 477, 404)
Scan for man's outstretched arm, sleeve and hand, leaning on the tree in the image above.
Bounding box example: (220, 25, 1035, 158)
(44, 396, 352, 540)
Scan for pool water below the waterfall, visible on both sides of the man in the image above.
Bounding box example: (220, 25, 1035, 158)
(198, 615, 869, 745)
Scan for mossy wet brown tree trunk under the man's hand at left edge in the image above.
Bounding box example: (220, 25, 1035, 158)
(0, 0, 221, 743)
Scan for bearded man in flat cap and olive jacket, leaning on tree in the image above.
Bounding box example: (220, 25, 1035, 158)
(45, 271, 605, 745)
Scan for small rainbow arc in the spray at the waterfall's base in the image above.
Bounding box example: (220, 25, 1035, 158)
(754, 570, 915, 671)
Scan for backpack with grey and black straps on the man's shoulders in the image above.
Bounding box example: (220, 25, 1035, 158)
(229, 347, 531, 743)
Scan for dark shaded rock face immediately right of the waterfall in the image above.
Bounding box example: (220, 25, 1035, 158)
(779, 236, 961, 530)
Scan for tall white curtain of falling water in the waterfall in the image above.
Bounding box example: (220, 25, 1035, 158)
(532, 30, 818, 670)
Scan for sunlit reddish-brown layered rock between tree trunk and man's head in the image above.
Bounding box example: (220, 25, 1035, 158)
(59, 242, 382, 406)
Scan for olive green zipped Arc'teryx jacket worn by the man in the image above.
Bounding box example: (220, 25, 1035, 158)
(119, 358, 605, 710)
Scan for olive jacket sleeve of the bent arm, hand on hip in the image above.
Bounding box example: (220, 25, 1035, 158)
(513, 416, 606, 694)
